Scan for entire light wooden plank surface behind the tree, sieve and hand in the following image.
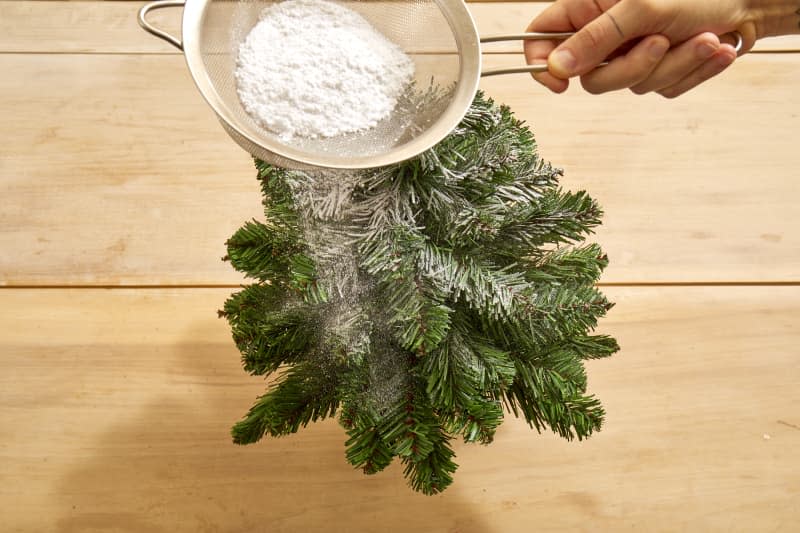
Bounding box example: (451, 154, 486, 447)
(0, 1, 800, 533)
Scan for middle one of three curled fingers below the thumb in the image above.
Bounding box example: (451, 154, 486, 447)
(631, 33, 720, 94)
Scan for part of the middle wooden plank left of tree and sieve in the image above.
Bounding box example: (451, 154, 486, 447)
(0, 55, 263, 284)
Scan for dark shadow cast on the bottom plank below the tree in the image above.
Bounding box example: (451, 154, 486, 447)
(57, 324, 488, 532)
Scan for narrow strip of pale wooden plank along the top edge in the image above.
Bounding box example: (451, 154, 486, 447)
(0, 0, 800, 53)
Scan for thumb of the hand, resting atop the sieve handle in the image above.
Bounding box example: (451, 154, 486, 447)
(547, 1, 644, 79)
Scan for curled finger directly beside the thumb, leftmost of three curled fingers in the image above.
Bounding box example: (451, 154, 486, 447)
(581, 35, 670, 94)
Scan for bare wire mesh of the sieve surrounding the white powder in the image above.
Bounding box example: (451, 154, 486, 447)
(197, 0, 462, 162)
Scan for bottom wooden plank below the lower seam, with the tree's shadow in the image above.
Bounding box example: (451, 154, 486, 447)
(0, 287, 800, 533)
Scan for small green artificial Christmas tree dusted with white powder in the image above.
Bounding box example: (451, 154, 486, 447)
(220, 94, 618, 494)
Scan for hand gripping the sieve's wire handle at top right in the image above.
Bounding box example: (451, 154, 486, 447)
(525, 0, 772, 97)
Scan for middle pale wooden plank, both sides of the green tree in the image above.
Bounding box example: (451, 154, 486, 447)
(0, 54, 800, 285)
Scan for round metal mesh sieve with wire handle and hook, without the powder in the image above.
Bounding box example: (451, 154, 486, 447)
(139, 0, 736, 169)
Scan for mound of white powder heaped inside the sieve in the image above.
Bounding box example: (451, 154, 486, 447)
(236, 0, 414, 141)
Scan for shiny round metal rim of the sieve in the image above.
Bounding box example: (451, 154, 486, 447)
(161, 0, 481, 169)
